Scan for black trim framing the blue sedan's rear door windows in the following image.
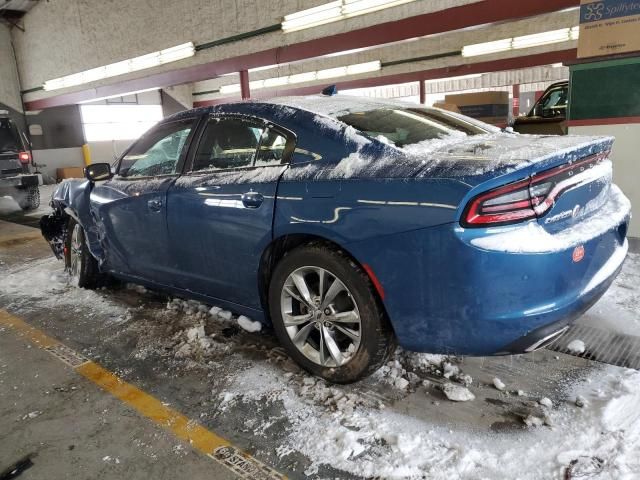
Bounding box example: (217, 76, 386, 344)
(182, 112, 298, 176)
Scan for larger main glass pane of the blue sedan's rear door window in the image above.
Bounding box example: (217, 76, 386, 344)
(192, 118, 265, 171)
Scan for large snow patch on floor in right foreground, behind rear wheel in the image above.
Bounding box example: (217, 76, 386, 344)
(219, 364, 640, 479)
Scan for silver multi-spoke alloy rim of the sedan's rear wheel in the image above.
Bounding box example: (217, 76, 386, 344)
(280, 266, 362, 367)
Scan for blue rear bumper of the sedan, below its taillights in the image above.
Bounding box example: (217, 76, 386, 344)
(347, 184, 630, 355)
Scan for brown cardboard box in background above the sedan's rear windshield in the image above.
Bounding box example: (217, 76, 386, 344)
(444, 92, 509, 125)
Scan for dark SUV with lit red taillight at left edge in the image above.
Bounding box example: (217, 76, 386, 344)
(0, 112, 40, 210)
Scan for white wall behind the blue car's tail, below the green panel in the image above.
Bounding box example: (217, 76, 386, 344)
(569, 123, 640, 238)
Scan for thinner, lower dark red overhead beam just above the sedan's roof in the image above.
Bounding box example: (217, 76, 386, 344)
(193, 48, 578, 107)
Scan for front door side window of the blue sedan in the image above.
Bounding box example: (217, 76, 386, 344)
(118, 120, 194, 177)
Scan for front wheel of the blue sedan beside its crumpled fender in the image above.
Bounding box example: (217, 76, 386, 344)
(64, 218, 104, 289)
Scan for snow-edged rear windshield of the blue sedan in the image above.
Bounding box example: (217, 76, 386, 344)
(338, 107, 493, 147)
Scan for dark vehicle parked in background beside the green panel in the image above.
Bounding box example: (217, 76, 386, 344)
(513, 80, 569, 135)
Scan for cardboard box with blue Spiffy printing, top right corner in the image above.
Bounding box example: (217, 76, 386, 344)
(578, 0, 640, 58)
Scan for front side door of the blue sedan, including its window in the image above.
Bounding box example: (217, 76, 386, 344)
(90, 118, 197, 283)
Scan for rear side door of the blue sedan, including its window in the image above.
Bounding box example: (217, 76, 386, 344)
(167, 115, 295, 308)
